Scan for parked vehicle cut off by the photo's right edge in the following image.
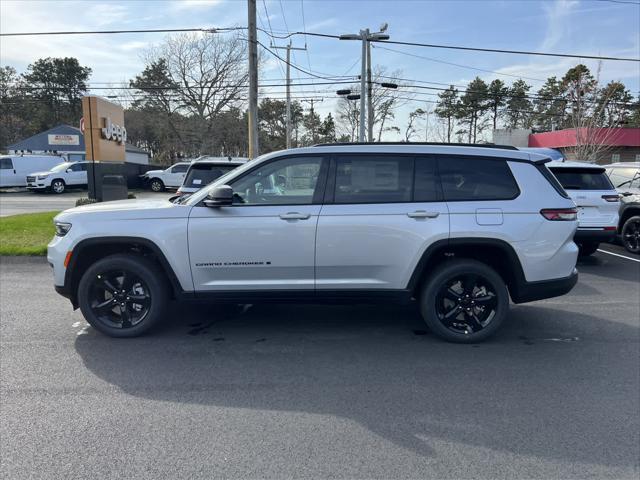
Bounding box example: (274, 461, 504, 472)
(605, 162, 640, 254)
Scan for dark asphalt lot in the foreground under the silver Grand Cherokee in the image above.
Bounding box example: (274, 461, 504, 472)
(0, 246, 640, 479)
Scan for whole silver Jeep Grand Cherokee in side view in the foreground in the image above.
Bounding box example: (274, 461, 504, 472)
(48, 144, 578, 342)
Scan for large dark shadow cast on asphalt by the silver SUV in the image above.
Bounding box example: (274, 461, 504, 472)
(75, 303, 640, 467)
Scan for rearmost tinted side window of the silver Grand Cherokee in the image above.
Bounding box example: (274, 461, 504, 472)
(438, 157, 519, 200)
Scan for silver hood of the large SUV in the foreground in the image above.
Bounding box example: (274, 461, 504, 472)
(56, 199, 190, 221)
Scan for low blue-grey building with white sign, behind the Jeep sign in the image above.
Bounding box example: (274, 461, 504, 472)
(6, 125, 149, 165)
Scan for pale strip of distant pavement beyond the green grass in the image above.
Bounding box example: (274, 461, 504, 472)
(0, 189, 175, 217)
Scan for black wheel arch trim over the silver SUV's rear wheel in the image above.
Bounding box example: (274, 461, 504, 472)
(407, 237, 526, 302)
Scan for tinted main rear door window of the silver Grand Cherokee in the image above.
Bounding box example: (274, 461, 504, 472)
(335, 156, 413, 203)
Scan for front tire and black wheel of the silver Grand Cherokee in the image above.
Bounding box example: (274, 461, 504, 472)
(78, 254, 170, 338)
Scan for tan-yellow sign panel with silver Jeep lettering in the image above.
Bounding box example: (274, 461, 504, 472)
(82, 97, 127, 163)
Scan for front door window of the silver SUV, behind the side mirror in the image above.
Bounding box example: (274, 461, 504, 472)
(231, 157, 322, 205)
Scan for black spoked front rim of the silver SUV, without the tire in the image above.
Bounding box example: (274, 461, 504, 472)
(89, 270, 152, 329)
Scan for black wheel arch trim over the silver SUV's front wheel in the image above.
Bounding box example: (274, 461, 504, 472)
(64, 236, 184, 307)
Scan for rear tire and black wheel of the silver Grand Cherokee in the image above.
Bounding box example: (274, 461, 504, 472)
(420, 259, 509, 343)
